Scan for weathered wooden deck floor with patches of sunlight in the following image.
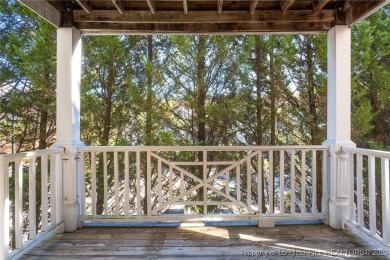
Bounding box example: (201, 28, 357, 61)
(23, 224, 384, 259)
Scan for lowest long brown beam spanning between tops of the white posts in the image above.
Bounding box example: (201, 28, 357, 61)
(75, 21, 334, 35)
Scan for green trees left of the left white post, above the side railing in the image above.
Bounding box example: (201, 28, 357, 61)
(0, 1, 56, 151)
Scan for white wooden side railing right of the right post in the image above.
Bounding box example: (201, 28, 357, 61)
(343, 147, 390, 248)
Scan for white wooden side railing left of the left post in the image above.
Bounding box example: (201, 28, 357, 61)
(0, 149, 63, 259)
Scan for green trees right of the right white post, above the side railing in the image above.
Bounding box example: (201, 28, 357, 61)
(352, 6, 390, 147)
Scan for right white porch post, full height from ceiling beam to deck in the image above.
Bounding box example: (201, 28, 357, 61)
(324, 25, 355, 229)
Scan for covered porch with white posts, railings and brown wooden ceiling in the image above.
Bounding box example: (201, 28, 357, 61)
(0, 0, 390, 259)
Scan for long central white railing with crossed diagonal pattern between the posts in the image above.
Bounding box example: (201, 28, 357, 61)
(78, 146, 329, 222)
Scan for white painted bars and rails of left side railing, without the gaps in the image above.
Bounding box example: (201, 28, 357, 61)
(0, 148, 64, 259)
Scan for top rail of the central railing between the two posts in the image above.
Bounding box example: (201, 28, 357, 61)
(77, 145, 329, 152)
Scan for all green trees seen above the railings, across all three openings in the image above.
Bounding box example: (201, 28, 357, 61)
(0, 0, 390, 151)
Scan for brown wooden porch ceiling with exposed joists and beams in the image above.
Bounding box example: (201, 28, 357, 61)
(20, 0, 390, 34)
